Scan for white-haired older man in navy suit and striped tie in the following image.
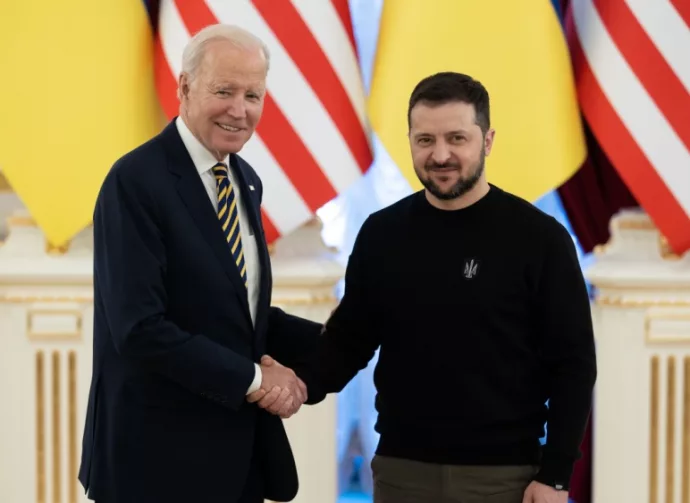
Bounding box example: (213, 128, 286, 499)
(79, 25, 322, 503)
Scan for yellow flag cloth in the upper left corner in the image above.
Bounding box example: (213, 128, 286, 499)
(0, 0, 161, 246)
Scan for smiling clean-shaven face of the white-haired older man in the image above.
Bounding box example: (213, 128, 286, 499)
(179, 40, 267, 161)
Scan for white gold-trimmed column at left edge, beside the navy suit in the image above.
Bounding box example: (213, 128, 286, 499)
(0, 214, 93, 503)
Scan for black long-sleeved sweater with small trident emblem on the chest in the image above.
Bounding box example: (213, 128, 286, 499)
(298, 186, 596, 488)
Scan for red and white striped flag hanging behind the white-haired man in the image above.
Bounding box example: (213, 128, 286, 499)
(155, 0, 372, 242)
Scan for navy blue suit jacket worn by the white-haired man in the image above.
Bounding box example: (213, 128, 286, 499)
(79, 121, 321, 503)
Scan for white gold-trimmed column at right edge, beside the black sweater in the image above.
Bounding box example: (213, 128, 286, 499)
(587, 212, 690, 503)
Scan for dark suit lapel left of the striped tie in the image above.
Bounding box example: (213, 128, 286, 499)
(161, 121, 251, 322)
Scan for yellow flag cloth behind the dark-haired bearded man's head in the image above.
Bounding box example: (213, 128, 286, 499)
(369, 0, 586, 201)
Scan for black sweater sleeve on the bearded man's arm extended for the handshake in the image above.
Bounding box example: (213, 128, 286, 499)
(294, 220, 380, 404)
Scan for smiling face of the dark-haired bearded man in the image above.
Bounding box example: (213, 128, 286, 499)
(410, 101, 494, 205)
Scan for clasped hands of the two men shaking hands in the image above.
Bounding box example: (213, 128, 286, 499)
(247, 355, 307, 419)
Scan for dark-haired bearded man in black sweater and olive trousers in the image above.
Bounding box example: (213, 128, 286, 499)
(249, 73, 596, 503)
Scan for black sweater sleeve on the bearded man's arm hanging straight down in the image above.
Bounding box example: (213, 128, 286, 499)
(535, 224, 597, 489)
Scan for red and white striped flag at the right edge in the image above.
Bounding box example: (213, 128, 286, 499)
(567, 0, 690, 253)
